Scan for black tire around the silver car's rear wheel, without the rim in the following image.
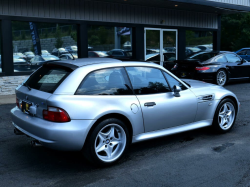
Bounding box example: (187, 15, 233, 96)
(83, 118, 131, 166)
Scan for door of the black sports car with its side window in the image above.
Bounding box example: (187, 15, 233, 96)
(225, 53, 249, 79)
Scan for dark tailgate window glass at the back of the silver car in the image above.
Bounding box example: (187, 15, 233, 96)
(26, 66, 72, 93)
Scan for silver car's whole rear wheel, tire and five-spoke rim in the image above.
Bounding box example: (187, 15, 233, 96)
(82, 118, 130, 166)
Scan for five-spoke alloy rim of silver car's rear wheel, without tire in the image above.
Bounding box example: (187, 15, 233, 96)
(95, 124, 127, 162)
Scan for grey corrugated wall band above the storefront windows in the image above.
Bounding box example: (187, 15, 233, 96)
(0, 0, 218, 29)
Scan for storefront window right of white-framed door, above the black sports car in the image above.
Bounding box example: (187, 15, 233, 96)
(186, 30, 213, 57)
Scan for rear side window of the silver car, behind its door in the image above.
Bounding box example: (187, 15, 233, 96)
(76, 68, 133, 95)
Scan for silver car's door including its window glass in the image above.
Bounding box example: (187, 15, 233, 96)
(126, 67, 197, 132)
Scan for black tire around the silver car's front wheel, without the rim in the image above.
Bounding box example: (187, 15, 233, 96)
(212, 98, 237, 133)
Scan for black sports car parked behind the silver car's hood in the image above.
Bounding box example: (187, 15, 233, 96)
(171, 51, 250, 86)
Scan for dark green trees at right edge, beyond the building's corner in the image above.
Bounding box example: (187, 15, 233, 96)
(221, 13, 250, 51)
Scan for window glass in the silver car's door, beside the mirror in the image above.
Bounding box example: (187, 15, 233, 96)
(126, 67, 171, 95)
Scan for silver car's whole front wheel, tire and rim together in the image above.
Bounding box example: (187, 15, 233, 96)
(213, 98, 237, 133)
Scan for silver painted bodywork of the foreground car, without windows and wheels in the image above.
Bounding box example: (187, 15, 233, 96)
(11, 59, 239, 150)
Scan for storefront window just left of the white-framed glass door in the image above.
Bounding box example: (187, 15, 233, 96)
(88, 25, 132, 59)
